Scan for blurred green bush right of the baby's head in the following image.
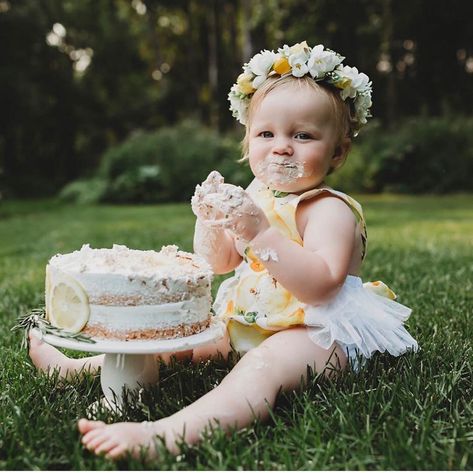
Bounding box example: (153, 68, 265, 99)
(330, 116, 473, 193)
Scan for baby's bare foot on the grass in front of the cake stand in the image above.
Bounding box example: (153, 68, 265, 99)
(78, 419, 177, 460)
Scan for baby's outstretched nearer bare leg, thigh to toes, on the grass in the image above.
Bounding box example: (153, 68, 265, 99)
(79, 328, 347, 458)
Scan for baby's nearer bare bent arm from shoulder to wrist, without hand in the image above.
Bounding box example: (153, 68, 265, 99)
(250, 197, 356, 305)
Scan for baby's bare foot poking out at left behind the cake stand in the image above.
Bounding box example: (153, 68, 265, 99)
(28, 332, 77, 378)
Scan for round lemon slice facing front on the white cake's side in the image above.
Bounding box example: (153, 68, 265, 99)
(48, 277, 90, 333)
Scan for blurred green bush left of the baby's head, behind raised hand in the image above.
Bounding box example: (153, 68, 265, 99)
(60, 121, 250, 203)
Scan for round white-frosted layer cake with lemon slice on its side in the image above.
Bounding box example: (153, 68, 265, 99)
(45, 245, 212, 340)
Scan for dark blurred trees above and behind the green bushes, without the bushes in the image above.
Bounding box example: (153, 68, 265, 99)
(0, 0, 473, 195)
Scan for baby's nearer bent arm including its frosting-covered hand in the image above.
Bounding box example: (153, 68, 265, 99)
(206, 183, 356, 305)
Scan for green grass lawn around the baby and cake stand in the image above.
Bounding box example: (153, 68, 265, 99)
(0, 195, 473, 470)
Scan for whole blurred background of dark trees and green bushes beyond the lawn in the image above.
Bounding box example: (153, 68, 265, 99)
(0, 0, 473, 203)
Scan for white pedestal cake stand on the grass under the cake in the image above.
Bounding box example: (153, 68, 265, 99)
(31, 319, 225, 411)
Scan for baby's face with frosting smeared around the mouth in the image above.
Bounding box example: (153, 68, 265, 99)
(245, 86, 340, 193)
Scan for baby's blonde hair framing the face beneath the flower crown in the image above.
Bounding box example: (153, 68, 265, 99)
(240, 75, 355, 162)
